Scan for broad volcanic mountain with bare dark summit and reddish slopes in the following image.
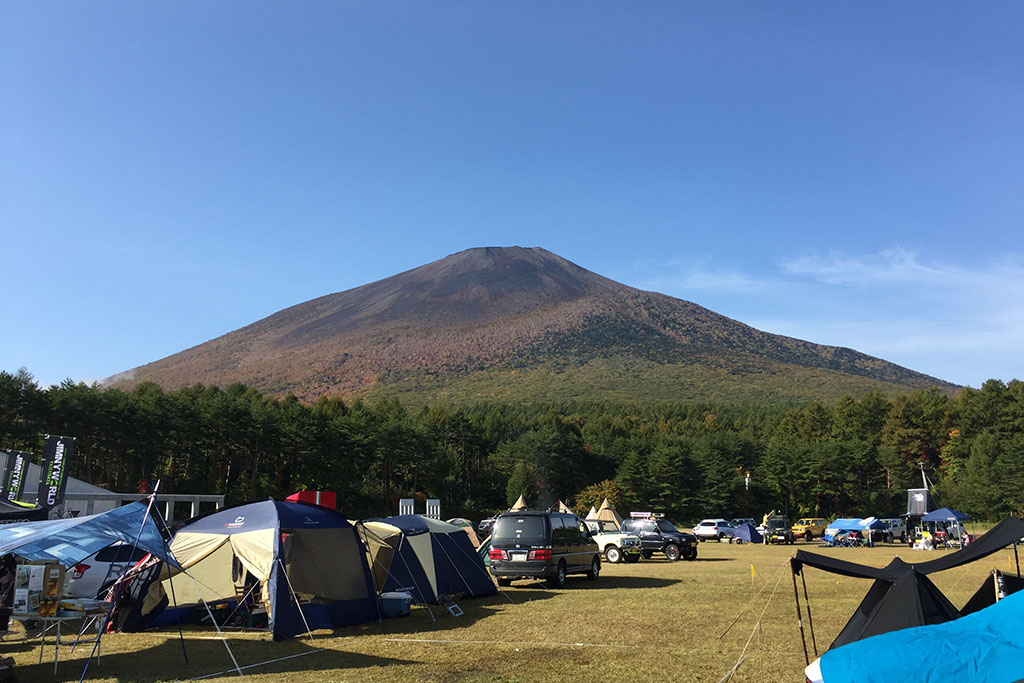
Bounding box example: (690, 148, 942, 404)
(106, 247, 952, 401)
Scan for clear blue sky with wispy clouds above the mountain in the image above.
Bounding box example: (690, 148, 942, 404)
(0, 0, 1024, 386)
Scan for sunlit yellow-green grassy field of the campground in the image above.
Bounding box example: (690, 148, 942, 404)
(6, 543, 1013, 683)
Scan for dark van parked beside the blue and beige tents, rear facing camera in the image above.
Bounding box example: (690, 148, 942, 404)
(488, 510, 601, 588)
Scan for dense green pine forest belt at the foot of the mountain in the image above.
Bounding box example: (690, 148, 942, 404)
(0, 369, 1024, 522)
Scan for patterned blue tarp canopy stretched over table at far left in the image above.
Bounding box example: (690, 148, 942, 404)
(0, 501, 178, 567)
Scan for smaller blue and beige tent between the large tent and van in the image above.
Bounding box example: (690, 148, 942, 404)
(361, 515, 498, 604)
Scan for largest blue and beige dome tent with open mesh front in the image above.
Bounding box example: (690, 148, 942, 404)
(142, 500, 380, 639)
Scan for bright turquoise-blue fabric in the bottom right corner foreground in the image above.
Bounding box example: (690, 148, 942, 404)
(820, 591, 1024, 683)
